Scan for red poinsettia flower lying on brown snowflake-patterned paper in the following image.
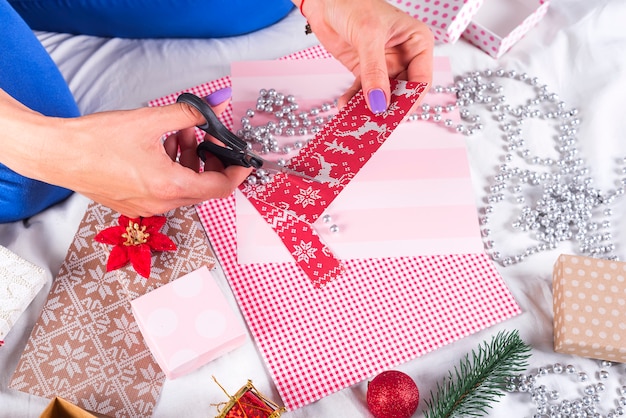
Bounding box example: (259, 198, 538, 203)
(94, 215, 176, 278)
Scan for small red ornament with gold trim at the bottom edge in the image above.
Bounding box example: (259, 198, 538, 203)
(213, 377, 285, 418)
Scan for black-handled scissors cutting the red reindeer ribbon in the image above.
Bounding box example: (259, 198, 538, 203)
(176, 93, 319, 182)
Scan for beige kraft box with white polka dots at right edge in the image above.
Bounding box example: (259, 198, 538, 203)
(552, 255, 626, 363)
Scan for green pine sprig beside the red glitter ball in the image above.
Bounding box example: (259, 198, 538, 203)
(425, 331, 530, 418)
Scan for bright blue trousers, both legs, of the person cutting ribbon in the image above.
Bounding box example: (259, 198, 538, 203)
(0, 0, 293, 223)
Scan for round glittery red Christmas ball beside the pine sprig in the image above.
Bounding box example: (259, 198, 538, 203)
(367, 370, 420, 418)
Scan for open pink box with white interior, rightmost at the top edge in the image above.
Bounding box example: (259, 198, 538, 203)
(463, 0, 550, 58)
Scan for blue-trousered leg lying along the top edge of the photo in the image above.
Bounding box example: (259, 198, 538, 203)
(9, 0, 294, 38)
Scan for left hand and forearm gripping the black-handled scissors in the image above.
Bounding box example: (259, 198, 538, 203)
(0, 90, 251, 217)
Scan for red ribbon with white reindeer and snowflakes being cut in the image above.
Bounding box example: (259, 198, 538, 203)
(240, 80, 428, 287)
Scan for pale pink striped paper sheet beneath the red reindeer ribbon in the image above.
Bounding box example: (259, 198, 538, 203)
(231, 57, 484, 264)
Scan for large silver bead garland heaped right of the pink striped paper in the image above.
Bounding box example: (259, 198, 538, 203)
(410, 69, 626, 266)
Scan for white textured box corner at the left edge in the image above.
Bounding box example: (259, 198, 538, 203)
(0, 246, 46, 346)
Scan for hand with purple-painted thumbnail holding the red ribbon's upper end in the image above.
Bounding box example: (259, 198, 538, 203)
(294, 0, 434, 113)
